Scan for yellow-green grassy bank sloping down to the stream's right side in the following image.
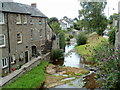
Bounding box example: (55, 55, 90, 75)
(75, 33, 108, 61)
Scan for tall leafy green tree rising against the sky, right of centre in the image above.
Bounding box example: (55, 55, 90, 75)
(79, 2, 107, 35)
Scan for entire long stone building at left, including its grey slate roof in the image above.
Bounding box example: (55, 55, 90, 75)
(0, 2, 58, 76)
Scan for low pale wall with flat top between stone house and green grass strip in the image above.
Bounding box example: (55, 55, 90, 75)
(0, 56, 41, 86)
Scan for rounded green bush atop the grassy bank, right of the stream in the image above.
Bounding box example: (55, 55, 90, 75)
(76, 32, 87, 45)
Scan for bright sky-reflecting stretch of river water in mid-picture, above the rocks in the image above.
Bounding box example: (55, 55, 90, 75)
(63, 39, 84, 68)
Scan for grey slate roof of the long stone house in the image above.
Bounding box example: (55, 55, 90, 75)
(2, 2, 46, 17)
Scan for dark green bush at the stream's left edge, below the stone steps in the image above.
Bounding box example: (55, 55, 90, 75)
(51, 49, 64, 61)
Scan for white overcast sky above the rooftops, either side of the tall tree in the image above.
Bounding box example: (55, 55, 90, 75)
(13, 0, 120, 19)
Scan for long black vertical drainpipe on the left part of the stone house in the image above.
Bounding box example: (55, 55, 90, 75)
(7, 13, 11, 73)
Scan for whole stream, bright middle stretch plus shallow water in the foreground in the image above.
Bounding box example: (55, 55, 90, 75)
(55, 39, 87, 88)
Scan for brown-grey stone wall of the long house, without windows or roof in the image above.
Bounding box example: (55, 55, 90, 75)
(0, 13, 47, 76)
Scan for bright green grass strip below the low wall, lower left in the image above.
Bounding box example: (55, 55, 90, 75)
(5, 61, 48, 88)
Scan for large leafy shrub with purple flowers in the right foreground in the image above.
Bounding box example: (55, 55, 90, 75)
(94, 43, 120, 88)
